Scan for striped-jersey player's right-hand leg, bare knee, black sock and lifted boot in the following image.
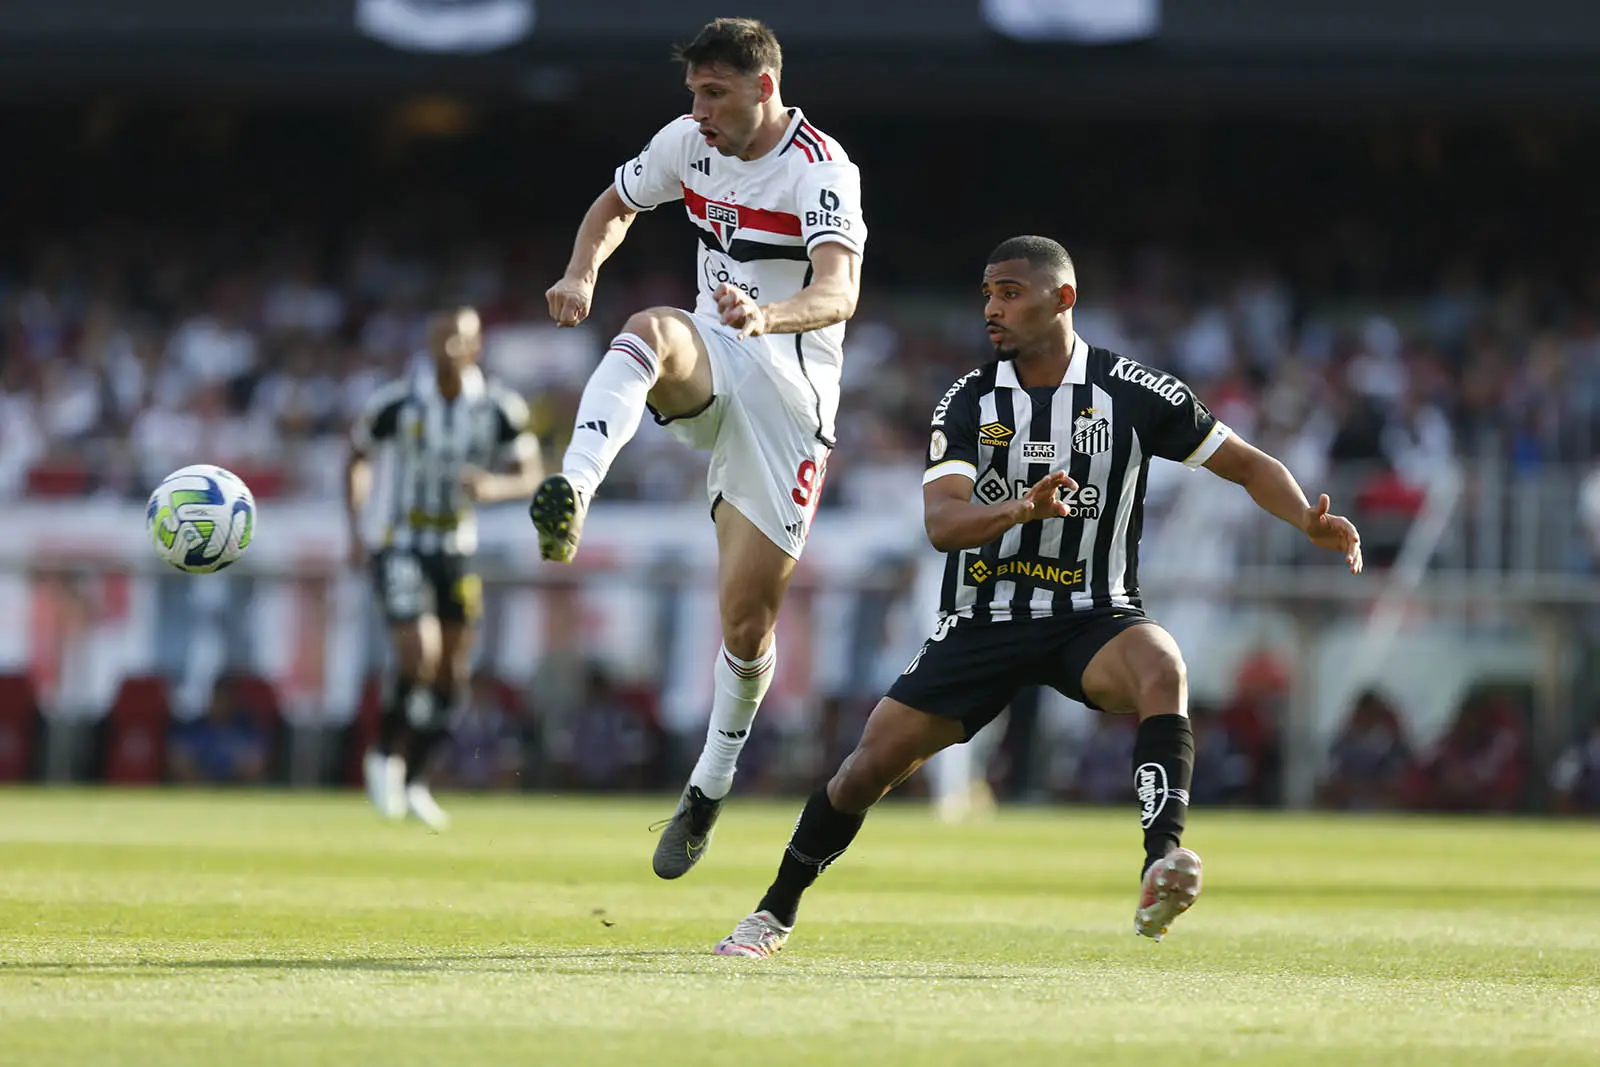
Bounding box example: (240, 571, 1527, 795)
(1082, 624, 1202, 941)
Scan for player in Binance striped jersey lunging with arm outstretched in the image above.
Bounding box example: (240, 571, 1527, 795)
(717, 237, 1362, 957)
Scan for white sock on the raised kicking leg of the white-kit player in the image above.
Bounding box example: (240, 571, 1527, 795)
(562, 333, 661, 496)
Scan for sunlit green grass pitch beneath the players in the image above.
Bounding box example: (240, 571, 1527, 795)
(0, 790, 1600, 1067)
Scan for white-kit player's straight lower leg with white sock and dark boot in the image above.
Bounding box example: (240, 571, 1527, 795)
(654, 501, 795, 878)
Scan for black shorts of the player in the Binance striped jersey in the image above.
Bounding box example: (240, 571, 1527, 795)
(888, 608, 1155, 739)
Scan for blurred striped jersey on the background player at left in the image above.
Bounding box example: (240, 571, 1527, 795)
(350, 363, 538, 555)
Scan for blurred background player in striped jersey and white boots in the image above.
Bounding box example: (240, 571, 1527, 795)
(346, 307, 541, 830)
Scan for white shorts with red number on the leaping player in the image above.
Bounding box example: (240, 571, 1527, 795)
(656, 312, 830, 560)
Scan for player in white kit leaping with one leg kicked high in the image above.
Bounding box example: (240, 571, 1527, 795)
(528, 19, 867, 878)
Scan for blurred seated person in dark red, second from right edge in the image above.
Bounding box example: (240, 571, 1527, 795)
(1406, 694, 1528, 813)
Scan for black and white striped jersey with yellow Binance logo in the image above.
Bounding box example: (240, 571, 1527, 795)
(923, 338, 1229, 622)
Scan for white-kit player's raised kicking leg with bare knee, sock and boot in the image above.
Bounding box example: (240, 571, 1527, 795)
(528, 307, 712, 563)
